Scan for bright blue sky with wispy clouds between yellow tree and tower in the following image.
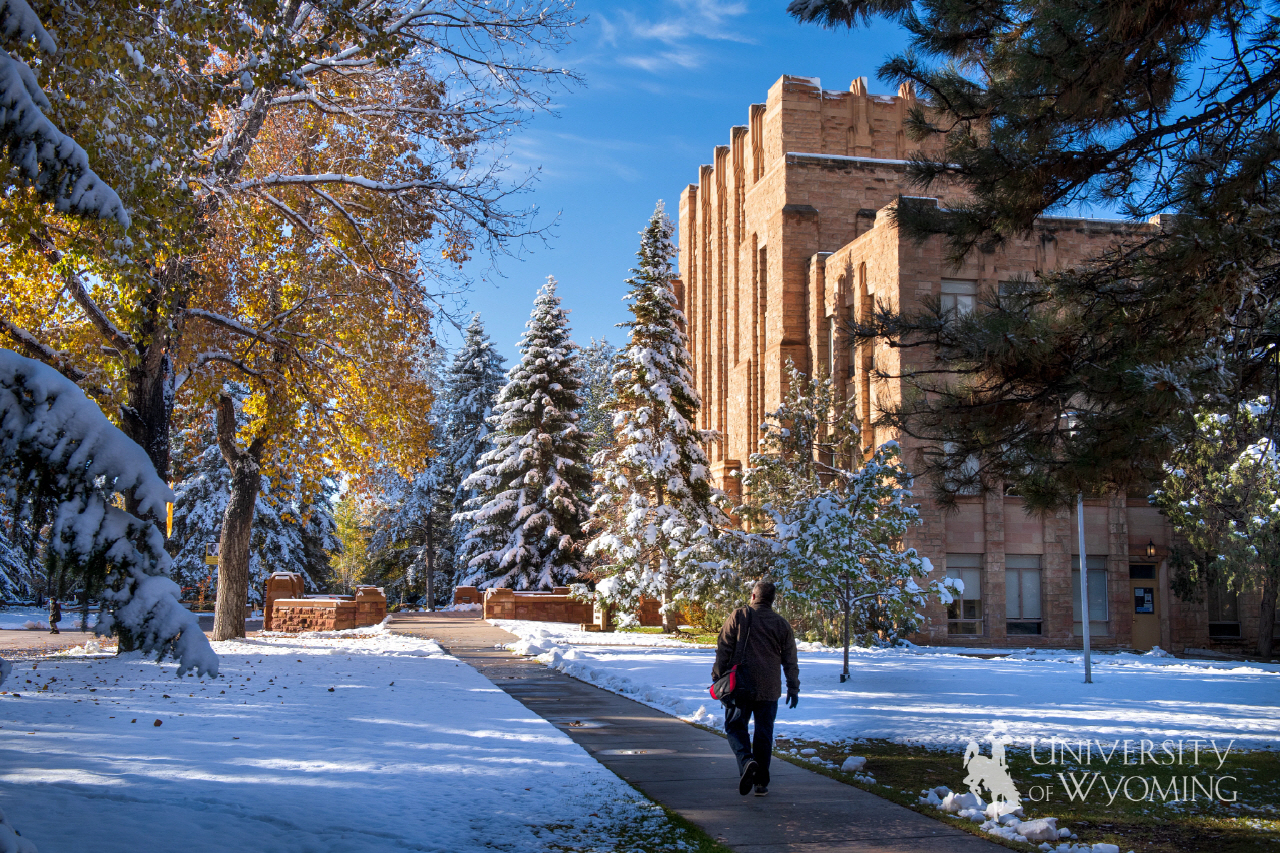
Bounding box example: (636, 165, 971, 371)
(442, 0, 905, 360)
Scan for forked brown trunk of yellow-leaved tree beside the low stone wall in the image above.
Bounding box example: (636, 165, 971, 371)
(214, 394, 262, 640)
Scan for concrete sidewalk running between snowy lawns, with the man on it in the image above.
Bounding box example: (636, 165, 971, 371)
(389, 613, 1007, 853)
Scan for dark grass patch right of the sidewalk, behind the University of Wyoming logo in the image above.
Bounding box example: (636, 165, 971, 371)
(776, 740, 1280, 853)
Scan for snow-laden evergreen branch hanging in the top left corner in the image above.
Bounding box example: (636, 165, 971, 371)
(0, 0, 131, 229)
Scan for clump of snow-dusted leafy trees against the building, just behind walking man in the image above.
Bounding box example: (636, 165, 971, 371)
(724, 362, 951, 653)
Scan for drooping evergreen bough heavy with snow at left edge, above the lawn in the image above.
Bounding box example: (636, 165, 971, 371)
(0, 350, 218, 674)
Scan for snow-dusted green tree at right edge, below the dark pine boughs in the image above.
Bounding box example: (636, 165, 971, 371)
(1152, 397, 1280, 657)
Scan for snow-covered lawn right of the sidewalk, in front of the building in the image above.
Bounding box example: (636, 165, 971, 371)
(494, 621, 1280, 748)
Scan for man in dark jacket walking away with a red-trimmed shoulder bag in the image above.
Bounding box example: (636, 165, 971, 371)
(712, 580, 800, 797)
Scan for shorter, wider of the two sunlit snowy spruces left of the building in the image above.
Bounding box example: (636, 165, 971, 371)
(456, 277, 590, 589)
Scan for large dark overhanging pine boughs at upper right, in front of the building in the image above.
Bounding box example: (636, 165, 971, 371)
(790, 0, 1280, 510)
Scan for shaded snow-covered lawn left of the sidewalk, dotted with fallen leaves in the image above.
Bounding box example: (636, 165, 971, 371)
(0, 628, 701, 853)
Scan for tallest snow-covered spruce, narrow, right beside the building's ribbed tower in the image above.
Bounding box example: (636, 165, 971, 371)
(589, 201, 727, 630)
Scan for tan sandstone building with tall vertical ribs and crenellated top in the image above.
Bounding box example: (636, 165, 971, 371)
(677, 77, 1275, 651)
